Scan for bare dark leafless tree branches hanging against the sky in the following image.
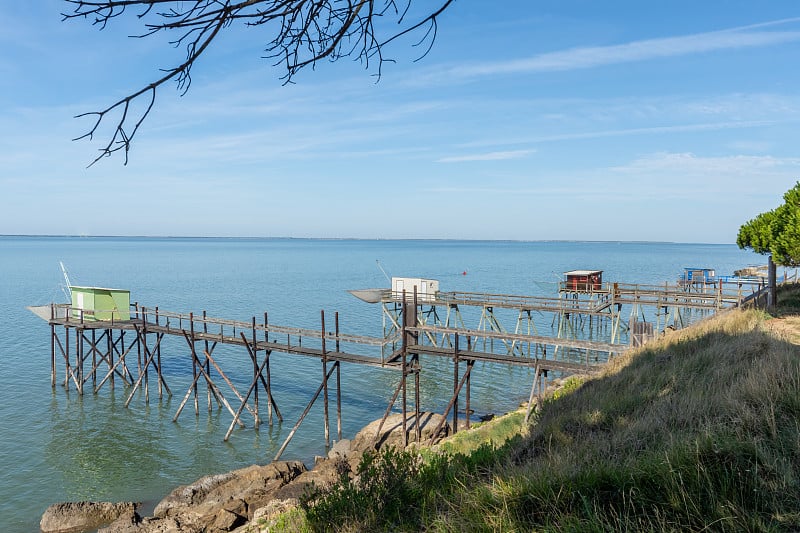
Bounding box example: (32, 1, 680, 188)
(62, 0, 455, 166)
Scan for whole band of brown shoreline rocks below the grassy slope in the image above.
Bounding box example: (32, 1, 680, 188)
(40, 413, 450, 533)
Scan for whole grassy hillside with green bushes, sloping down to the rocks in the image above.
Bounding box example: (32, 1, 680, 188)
(270, 287, 800, 532)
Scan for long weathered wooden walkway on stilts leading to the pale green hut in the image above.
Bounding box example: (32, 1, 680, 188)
(38, 303, 612, 459)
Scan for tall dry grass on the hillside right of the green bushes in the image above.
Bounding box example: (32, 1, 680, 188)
(442, 296, 800, 531)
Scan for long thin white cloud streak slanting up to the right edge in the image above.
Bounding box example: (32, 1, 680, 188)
(446, 18, 800, 78)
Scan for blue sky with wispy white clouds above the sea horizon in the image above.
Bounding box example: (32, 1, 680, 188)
(0, 0, 800, 243)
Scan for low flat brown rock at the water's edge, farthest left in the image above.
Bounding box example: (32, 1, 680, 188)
(39, 502, 138, 533)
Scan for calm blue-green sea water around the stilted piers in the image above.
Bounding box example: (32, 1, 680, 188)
(0, 237, 763, 532)
